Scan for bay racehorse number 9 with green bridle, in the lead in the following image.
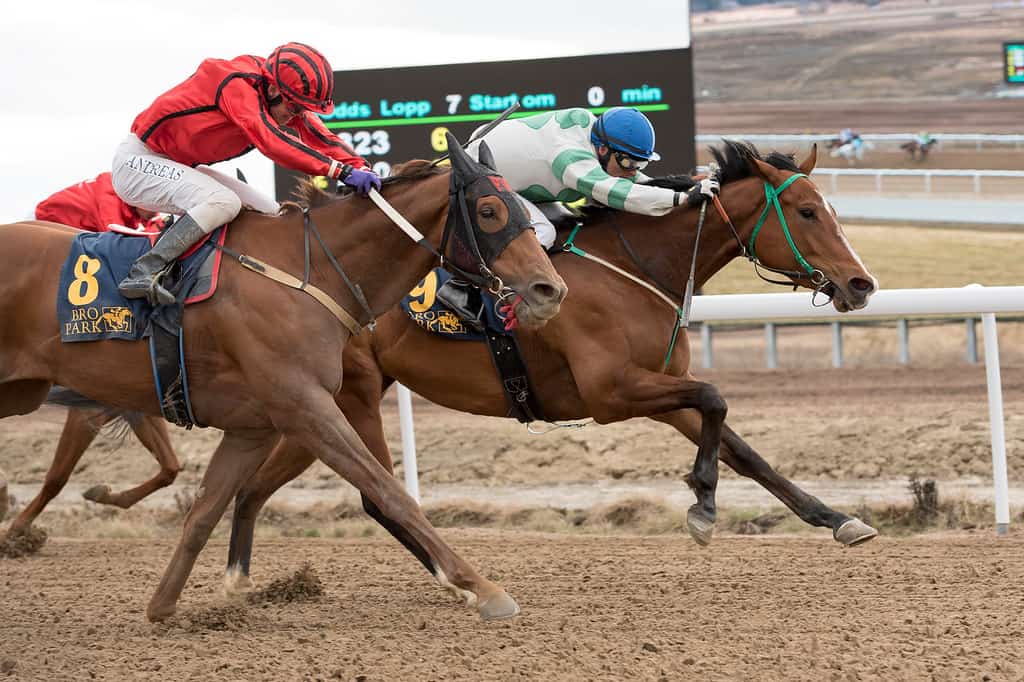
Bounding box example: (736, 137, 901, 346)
(227, 140, 878, 589)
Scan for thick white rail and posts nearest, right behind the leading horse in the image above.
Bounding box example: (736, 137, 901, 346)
(397, 285, 1024, 536)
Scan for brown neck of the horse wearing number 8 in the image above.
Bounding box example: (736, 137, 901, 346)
(310, 173, 449, 323)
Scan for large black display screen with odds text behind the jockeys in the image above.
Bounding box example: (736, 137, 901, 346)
(274, 48, 695, 200)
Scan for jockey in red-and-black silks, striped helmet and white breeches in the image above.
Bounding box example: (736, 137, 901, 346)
(113, 43, 380, 304)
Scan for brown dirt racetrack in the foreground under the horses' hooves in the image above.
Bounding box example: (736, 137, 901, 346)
(0, 530, 1024, 681)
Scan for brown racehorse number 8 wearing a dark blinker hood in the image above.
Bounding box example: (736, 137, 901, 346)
(0, 137, 566, 621)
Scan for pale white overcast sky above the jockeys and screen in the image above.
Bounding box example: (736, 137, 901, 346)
(0, 0, 690, 222)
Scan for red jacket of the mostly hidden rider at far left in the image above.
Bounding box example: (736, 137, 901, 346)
(36, 173, 143, 232)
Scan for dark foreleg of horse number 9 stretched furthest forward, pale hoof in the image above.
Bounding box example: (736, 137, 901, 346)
(651, 410, 879, 547)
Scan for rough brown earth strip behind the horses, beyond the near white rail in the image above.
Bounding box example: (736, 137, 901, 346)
(0, 360, 1024, 493)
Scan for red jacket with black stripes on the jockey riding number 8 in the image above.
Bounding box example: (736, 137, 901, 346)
(131, 55, 368, 177)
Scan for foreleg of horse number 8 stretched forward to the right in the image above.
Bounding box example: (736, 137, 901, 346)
(274, 385, 519, 620)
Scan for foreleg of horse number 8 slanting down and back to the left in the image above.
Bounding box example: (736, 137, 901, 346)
(145, 431, 278, 621)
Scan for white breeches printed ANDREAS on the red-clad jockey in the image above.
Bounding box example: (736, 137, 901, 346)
(113, 134, 281, 232)
